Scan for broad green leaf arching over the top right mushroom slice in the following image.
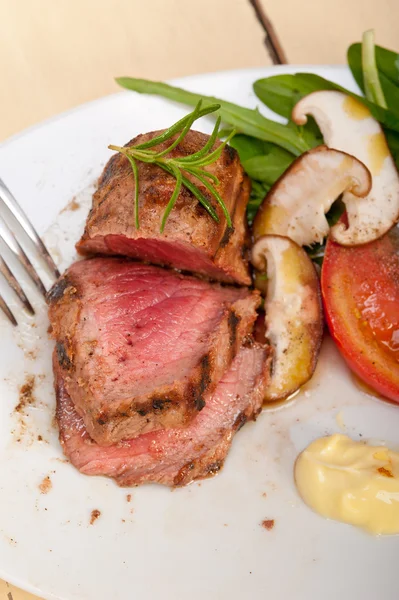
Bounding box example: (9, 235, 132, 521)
(254, 73, 399, 132)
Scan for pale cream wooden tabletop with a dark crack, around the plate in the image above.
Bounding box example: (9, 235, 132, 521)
(0, 0, 399, 600)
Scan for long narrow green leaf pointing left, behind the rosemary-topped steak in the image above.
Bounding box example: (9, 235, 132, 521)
(116, 77, 309, 156)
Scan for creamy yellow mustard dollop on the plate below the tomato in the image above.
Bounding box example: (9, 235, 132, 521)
(295, 434, 399, 535)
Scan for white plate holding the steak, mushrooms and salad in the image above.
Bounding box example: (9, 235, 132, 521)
(0, 67, 399, 600)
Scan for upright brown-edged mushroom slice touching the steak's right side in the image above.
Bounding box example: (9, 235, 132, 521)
(252, 235, 323, 402)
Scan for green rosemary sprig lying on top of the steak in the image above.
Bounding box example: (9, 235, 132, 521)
(108, 100, 236, 233)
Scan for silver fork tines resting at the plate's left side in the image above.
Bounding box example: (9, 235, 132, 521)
(0, 179, 60, 326)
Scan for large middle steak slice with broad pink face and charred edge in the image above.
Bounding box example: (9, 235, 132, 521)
(49, 258, 259, 445)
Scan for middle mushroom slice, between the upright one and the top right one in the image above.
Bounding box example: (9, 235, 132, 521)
(253, 146, 371, 246)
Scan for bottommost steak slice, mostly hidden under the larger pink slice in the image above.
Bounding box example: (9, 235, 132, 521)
(54, 344, 269, 486)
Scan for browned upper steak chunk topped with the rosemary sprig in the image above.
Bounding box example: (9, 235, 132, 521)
(77, 131, 251, 285)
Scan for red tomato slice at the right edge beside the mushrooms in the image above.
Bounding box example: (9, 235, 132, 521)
(321, 227, 399, 403)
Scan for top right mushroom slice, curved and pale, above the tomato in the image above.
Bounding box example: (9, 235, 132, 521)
(292, 91, 399, 246)
